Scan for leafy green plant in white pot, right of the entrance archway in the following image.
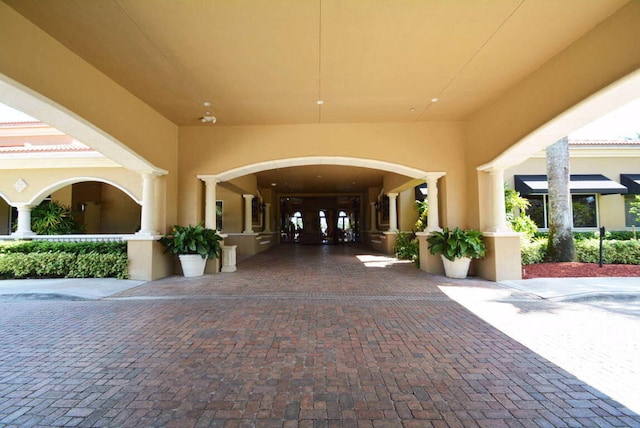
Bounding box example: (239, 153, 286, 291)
(427, 227, 487, 278)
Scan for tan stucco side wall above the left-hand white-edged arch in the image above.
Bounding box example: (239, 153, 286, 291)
(0, 2, 177, 231)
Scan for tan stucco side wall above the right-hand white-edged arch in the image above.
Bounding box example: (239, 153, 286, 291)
(465, 1, 640, 231)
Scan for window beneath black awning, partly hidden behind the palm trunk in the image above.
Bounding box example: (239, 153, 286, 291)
(524, 194, 598, 229)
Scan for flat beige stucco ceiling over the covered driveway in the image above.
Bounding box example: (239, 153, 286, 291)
(4, 0, 628, 126)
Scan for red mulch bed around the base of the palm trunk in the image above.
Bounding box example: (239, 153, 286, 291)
(522, 262, 640, 279)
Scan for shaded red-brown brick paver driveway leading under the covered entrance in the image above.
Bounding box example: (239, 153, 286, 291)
(0, 245, 640, 427)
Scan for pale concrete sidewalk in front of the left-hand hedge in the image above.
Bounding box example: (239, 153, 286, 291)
(0, 278, 146, 300)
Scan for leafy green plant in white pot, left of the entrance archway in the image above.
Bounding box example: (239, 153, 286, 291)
(159, 223, 222, 277)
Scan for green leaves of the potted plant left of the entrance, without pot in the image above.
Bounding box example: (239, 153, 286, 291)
(160, 223, 222, 259)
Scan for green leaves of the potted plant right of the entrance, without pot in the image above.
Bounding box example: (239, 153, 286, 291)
(427, 227, 486, 261)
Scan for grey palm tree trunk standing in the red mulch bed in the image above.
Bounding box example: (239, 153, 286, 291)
(547, 137, 576, 262)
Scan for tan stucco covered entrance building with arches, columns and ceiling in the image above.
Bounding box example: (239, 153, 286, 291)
(0, 0, 640, 280)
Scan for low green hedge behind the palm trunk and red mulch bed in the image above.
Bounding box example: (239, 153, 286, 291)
(520, 239, 640, 265)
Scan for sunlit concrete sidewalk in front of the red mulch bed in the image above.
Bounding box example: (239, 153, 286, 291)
(498, 277, 640, 302)
